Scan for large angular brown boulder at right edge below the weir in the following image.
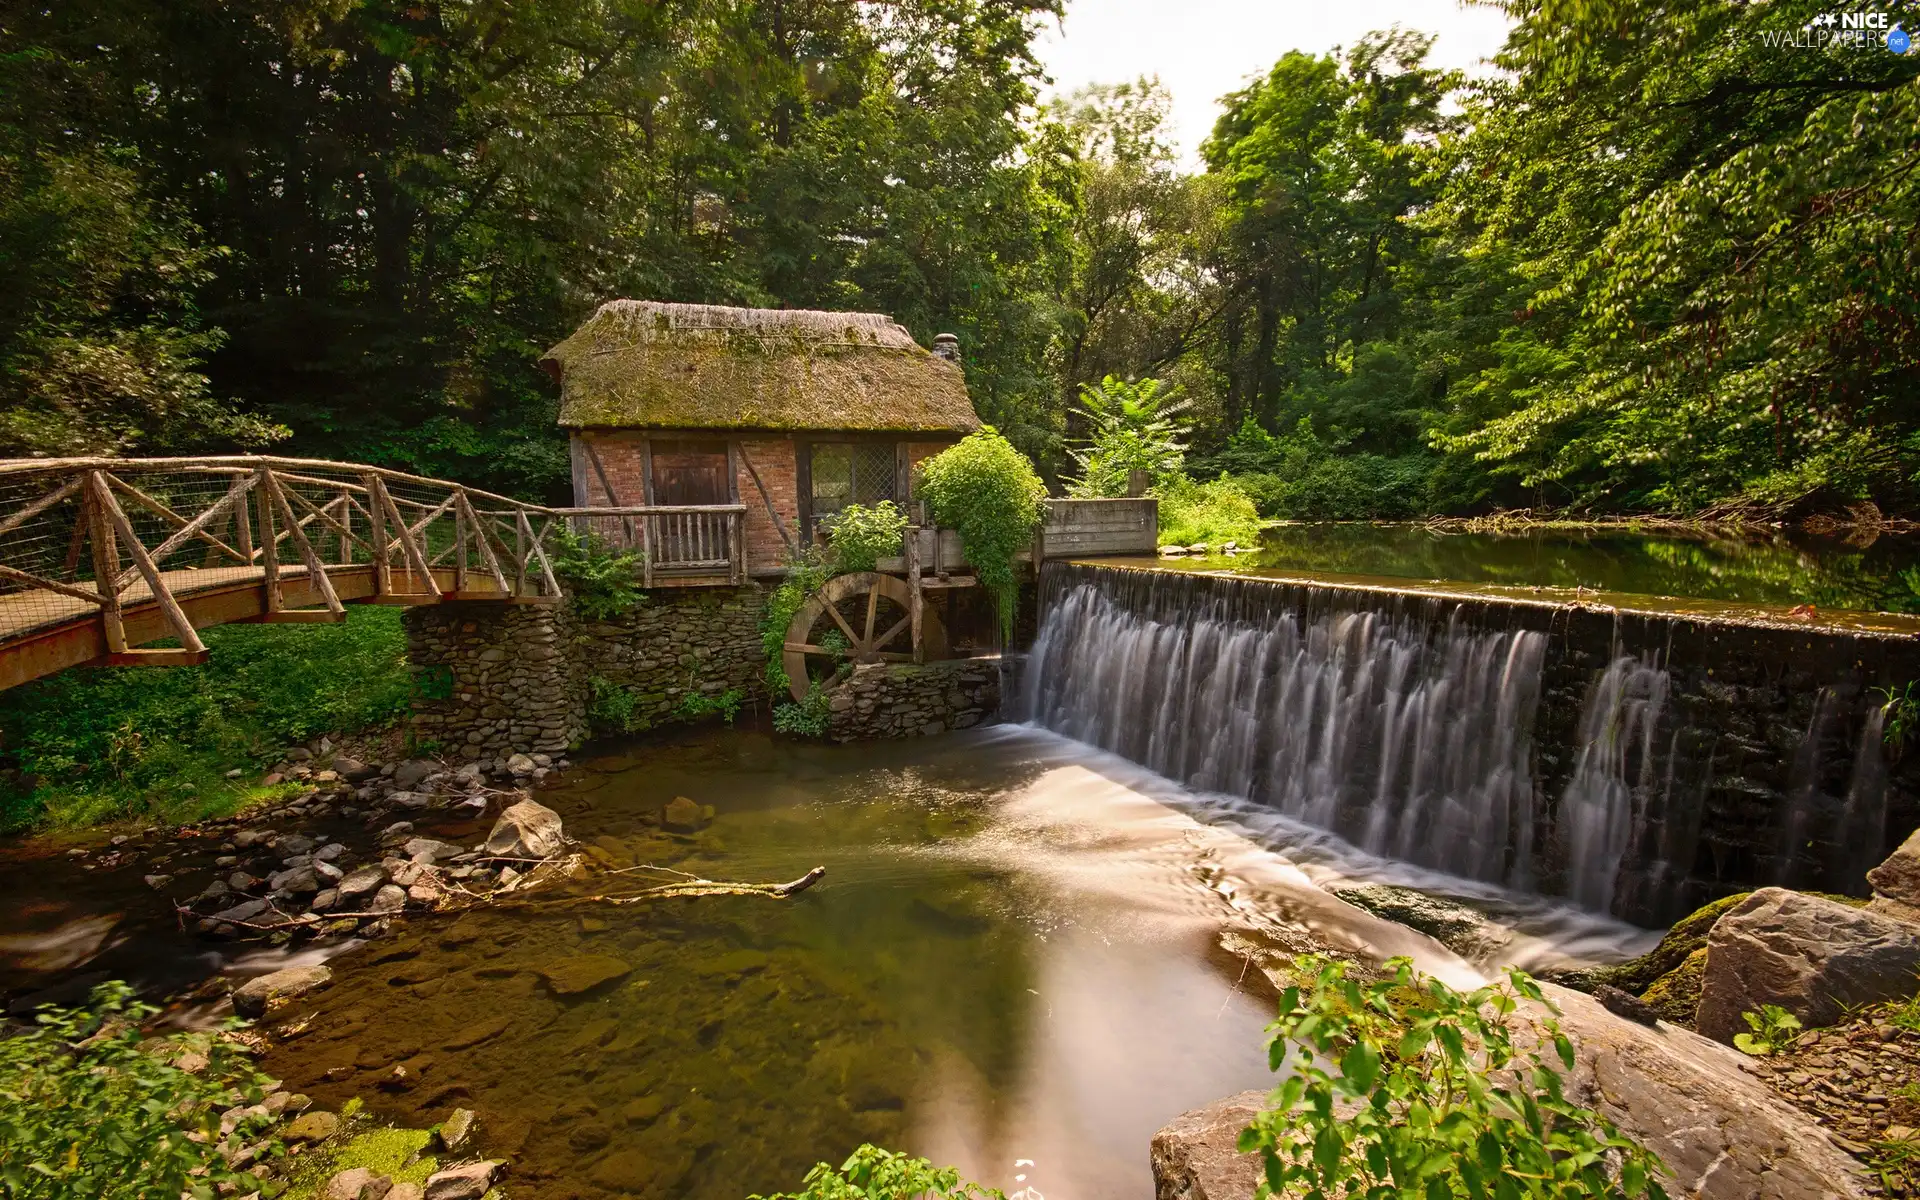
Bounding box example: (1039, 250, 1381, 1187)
(1693, 887, 1920, 1043)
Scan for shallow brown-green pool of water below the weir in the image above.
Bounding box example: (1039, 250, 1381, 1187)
(10, 726, 1651, 1200)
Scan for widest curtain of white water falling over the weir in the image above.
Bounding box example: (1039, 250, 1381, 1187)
(1023, 574, 1548, 887)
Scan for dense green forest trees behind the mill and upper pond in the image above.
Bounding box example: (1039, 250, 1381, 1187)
(0, 0, 1920, 516)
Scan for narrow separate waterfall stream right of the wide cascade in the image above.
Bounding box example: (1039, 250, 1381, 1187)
(1559, 655, 1672, 912)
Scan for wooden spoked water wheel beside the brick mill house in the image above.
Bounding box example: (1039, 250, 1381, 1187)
(783, 570, 947, 701)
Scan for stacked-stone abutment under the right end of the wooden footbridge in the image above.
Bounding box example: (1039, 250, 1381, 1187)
(405, 603, 588, 758)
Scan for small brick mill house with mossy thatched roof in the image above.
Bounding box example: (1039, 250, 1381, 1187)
(540, 300, 979, 588)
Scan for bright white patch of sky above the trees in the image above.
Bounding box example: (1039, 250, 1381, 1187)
(1041, 0, 1507, 165)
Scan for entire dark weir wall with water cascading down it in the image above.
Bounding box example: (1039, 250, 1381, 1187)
(1020, 563, 1920, 925)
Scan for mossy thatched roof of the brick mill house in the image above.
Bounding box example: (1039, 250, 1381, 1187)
(541, 300, 979, 432)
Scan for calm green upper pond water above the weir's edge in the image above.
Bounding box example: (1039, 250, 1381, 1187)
(1238, 522, 1920, 612)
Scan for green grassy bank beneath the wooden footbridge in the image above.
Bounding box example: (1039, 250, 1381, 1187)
(0, 607, 413, 831)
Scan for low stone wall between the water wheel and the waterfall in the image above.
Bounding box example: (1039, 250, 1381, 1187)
(828, 659, 1000, 741)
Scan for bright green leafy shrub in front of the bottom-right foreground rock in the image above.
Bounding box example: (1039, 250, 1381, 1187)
(1240, 956, 1667, 1200)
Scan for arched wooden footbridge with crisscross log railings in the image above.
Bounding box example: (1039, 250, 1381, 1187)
(0, 455, 637, 689)
